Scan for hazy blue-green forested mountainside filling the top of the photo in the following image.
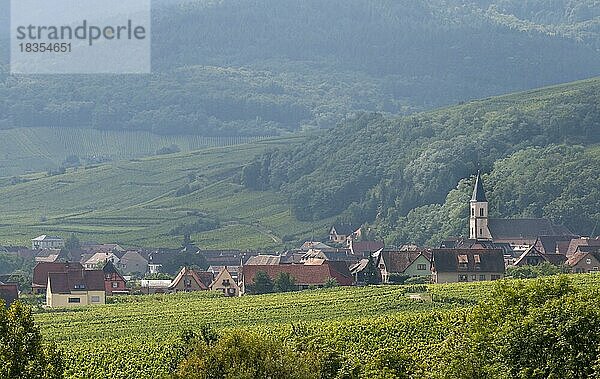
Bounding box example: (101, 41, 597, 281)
(0, 0, 600, 136)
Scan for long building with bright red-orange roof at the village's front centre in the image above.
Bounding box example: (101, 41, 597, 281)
(240, 262, 354, 294)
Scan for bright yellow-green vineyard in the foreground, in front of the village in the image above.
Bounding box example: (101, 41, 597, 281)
(31, 275, 600, 378)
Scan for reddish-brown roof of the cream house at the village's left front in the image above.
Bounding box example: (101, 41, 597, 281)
(48, 270, 104, 294)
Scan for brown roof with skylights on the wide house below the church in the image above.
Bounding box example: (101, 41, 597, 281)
(431, 249, 504, 273)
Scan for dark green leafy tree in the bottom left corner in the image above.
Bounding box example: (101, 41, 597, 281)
(0, 301, 64, 379)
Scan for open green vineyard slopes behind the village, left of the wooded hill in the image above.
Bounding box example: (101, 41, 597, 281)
(0, 137, 330, 250)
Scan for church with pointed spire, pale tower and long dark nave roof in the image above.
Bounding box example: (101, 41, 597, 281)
(469, 173, 573, 245)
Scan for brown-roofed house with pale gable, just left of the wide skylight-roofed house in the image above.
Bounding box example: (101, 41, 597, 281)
(374, 249, 431, 283)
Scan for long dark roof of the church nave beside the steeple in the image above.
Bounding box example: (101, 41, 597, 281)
(488, 218, 573, 239)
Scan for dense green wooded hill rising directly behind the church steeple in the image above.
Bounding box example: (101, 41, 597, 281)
(242, 79, 600, 243)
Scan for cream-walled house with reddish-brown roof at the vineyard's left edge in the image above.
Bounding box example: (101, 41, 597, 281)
(46, 267, 106, 308)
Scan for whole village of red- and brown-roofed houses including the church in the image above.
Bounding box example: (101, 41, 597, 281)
(0, 174, 600, 308)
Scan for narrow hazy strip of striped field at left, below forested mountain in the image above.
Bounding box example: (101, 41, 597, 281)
(0, 127, 264, 177)
